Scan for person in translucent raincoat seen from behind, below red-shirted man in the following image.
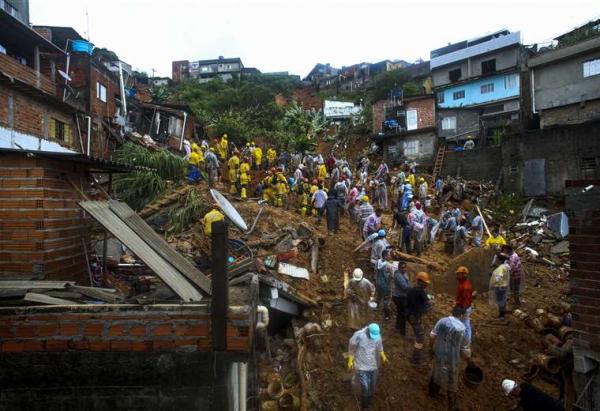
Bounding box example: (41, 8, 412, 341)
(429, 306, 471, 411)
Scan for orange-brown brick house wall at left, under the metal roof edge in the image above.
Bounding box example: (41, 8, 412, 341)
(0, 153, 91, 284)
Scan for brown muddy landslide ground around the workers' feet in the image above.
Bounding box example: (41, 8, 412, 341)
(166, 180, 568, 410)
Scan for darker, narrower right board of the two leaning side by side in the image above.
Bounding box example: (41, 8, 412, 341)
(109, 200, 211, 295)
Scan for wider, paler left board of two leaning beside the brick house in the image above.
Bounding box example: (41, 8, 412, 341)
(79, 201, 202, 302)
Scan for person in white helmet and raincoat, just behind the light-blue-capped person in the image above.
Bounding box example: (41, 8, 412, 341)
(344, 268, 375, 330)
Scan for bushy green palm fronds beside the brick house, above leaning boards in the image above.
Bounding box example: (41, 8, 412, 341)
(114, 143, 186, 210)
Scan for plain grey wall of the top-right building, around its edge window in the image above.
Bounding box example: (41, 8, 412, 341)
(532, 48, 600, 111)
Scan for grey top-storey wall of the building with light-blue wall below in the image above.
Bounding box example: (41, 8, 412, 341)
(431, 47, 520, 87)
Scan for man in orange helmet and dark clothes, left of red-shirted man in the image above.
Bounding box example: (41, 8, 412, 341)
(406, 271, 431, 366)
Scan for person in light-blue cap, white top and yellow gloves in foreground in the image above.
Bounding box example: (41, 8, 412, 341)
(348, 323, 388, 410)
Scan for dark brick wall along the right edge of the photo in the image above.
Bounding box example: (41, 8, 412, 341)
(566, 180, 600, 351)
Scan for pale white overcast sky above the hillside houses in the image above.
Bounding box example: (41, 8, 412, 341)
(30, 0, 600, 77)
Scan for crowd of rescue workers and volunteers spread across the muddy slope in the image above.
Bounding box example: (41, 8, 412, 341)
(186, 135, 562, 410)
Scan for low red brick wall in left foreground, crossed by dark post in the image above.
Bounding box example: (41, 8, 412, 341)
(0, 305, 252, 353)
